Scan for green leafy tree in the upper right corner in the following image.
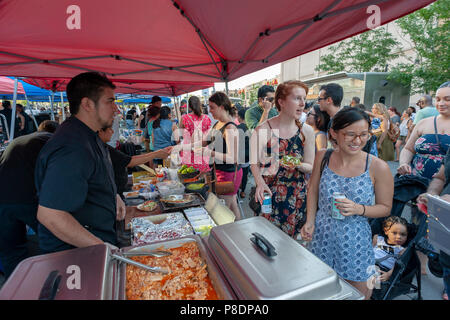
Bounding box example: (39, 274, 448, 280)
(389, 0, 450, 93)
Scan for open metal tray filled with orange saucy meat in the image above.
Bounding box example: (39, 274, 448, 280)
(119, 235, 235, 300)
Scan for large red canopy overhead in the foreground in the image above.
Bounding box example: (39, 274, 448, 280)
(0, 0, 433, 94)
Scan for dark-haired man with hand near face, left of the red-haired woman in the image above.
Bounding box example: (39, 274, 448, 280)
(245, 85, 278, 130)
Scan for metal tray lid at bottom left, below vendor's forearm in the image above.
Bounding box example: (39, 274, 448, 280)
(0, 244, 117, 300)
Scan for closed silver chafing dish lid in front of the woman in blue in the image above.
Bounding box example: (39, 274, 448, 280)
(207, 217, 363, 300)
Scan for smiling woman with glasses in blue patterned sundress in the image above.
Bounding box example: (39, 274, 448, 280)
(301, 108, 394, 299)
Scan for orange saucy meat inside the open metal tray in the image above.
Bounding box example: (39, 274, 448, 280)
(126, 241, 219, 300)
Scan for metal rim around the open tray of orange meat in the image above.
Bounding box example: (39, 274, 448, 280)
(112, 235, 236, 300)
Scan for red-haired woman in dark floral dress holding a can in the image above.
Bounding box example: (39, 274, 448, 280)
(250, 81, 315, 238)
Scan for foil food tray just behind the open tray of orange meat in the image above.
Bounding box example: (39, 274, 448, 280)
(130, 212, 194, 245)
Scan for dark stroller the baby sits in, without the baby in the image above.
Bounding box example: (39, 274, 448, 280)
(371, 210, 427, 300)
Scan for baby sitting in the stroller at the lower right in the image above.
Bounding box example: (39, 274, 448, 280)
(373, 216, 408, 282)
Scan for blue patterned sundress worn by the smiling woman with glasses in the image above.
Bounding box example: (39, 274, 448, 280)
(311, 156, 375, 281)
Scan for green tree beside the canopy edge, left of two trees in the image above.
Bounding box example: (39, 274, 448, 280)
(316, 27, 399, 73)
